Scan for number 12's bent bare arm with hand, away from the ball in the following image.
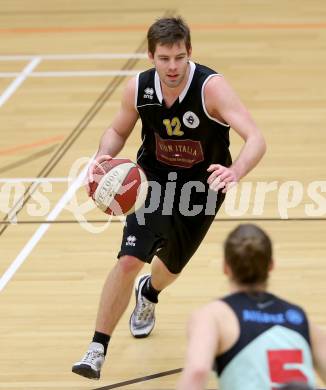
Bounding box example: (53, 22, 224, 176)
(204, 76, 266, 192)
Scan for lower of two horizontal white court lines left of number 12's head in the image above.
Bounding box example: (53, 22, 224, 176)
(0, 70, 142, 78)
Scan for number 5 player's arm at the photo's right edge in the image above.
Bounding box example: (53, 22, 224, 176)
(309, 323, 326, 383)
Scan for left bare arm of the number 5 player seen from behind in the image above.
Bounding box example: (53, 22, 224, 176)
(177, 304, 219, 390)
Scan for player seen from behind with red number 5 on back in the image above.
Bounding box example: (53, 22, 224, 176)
(177, 224, 326, 390)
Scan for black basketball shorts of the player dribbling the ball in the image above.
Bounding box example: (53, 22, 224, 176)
(118, 183, 225, 274)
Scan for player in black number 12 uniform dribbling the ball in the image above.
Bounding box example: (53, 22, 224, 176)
(72, 18, 265, 379)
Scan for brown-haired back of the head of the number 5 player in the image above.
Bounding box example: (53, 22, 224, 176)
(224, 224, 272, 285)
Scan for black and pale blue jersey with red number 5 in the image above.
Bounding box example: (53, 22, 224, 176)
(215, 292, 314, 390)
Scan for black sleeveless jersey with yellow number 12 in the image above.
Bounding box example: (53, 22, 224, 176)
(136, 62, 231, 180)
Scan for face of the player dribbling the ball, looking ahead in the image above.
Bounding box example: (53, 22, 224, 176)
(149, 41, 191, 88)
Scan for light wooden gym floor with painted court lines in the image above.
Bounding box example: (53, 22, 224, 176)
(0, 0, 326, 390)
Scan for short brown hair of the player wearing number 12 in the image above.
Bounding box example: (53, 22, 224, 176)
(147, 17, 191, 55)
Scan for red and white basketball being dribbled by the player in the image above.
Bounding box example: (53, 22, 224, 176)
(89, 158, 148, 215)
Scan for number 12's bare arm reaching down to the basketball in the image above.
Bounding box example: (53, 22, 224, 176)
(96, 78, 138, 157)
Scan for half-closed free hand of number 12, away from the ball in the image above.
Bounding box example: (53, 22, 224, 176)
(207, 164, 239, 194)
